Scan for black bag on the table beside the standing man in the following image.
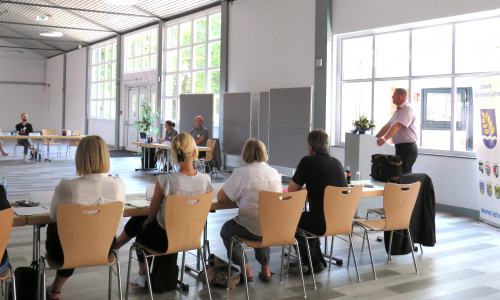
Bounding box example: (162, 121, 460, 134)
(370, 154, 403, 183)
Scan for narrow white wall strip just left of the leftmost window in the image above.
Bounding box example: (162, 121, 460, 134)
(65, 48, 87, 132)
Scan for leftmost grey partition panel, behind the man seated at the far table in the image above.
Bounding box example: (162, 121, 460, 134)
(178, 94, 214, 137)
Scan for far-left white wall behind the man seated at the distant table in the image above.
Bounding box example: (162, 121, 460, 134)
(0, 39, 45, 131)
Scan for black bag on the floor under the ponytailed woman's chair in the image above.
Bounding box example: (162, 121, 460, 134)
(151, 253, 179, 294)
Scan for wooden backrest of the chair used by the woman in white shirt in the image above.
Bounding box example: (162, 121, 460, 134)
(259, 190, 307, 247)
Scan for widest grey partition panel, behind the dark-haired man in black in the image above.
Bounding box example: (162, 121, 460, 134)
(269, 87, 313, 168)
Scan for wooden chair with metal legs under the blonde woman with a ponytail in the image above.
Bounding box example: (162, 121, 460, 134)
(125, 192, 214, 299)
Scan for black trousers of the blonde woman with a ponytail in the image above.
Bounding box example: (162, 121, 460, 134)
(124, 216, 170, 262)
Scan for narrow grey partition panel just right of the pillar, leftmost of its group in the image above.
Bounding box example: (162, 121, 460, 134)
(222, 93, 252, 155)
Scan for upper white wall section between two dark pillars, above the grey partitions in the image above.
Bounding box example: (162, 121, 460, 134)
(228, 0, 315, 92)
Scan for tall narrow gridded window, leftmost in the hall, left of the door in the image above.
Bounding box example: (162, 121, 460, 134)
(88, 40, 117, 120)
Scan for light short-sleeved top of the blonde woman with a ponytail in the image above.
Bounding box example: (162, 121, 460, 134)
(156, 172, 214, 229)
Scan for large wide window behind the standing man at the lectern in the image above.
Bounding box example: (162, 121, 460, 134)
(336, 16, 500, 155)
